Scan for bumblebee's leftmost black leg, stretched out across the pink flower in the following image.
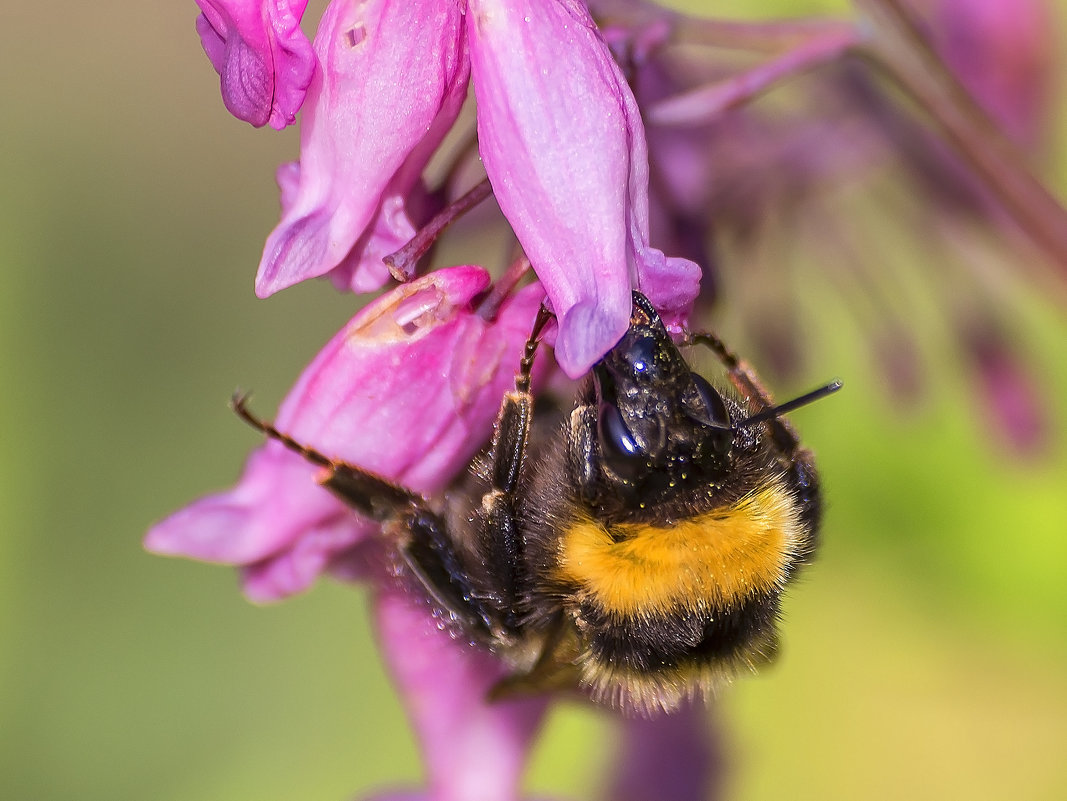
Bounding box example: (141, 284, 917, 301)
(232, 396, 492, 635)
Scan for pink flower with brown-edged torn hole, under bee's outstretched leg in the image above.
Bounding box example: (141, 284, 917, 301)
(145, 267, 542, 600)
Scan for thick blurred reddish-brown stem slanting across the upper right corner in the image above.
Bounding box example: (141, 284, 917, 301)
(856, 0, 1067, 273)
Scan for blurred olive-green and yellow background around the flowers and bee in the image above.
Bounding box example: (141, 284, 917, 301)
(0, 0, 1067, 801)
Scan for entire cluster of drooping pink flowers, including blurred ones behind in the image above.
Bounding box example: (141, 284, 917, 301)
(154, 0, 1067, 801)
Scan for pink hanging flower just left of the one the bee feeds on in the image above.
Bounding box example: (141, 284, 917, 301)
(256, 0, 468, 297)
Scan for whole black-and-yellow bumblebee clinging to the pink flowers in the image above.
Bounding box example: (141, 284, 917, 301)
(234, 292, 840, 714)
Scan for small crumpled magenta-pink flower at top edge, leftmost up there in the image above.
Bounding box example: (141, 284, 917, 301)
(196, 0, 315, 130)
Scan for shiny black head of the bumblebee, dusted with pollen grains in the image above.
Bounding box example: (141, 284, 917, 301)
(593, 292, 742, 492)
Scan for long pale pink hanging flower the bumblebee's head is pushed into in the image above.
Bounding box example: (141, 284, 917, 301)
(467, 0, 700, 378)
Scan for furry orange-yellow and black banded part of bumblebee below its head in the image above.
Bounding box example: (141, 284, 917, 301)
(557, 481, 811, 709)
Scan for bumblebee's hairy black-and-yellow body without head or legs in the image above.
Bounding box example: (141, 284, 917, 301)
(507, 398, 818, 712)
